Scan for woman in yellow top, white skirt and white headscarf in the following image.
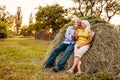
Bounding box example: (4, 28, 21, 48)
(68, 20, 94, 74)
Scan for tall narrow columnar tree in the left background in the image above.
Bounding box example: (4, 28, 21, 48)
(15, 7, 22, 34)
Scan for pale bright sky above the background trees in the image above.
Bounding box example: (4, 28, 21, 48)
(0, 0, 120, 25)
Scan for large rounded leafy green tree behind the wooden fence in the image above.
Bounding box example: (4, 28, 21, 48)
(35, 4, 67, 31)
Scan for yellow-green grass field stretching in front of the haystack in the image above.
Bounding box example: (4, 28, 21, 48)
(0, 37, 120, 80)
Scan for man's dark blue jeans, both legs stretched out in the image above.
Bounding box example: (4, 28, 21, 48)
(45, 43, 74, 71)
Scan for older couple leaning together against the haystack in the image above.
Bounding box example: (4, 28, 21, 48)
(44, 19, 94, 74)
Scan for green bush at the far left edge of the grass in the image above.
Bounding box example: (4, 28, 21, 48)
(0, 21, 7, 38)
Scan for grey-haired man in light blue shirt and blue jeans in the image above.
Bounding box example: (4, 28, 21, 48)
(44, 19, 80, 72)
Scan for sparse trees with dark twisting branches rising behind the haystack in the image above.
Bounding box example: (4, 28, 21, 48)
(73, 0, 120, 21)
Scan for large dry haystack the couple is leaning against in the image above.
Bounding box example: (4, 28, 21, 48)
(44, 17, 120, 73)
